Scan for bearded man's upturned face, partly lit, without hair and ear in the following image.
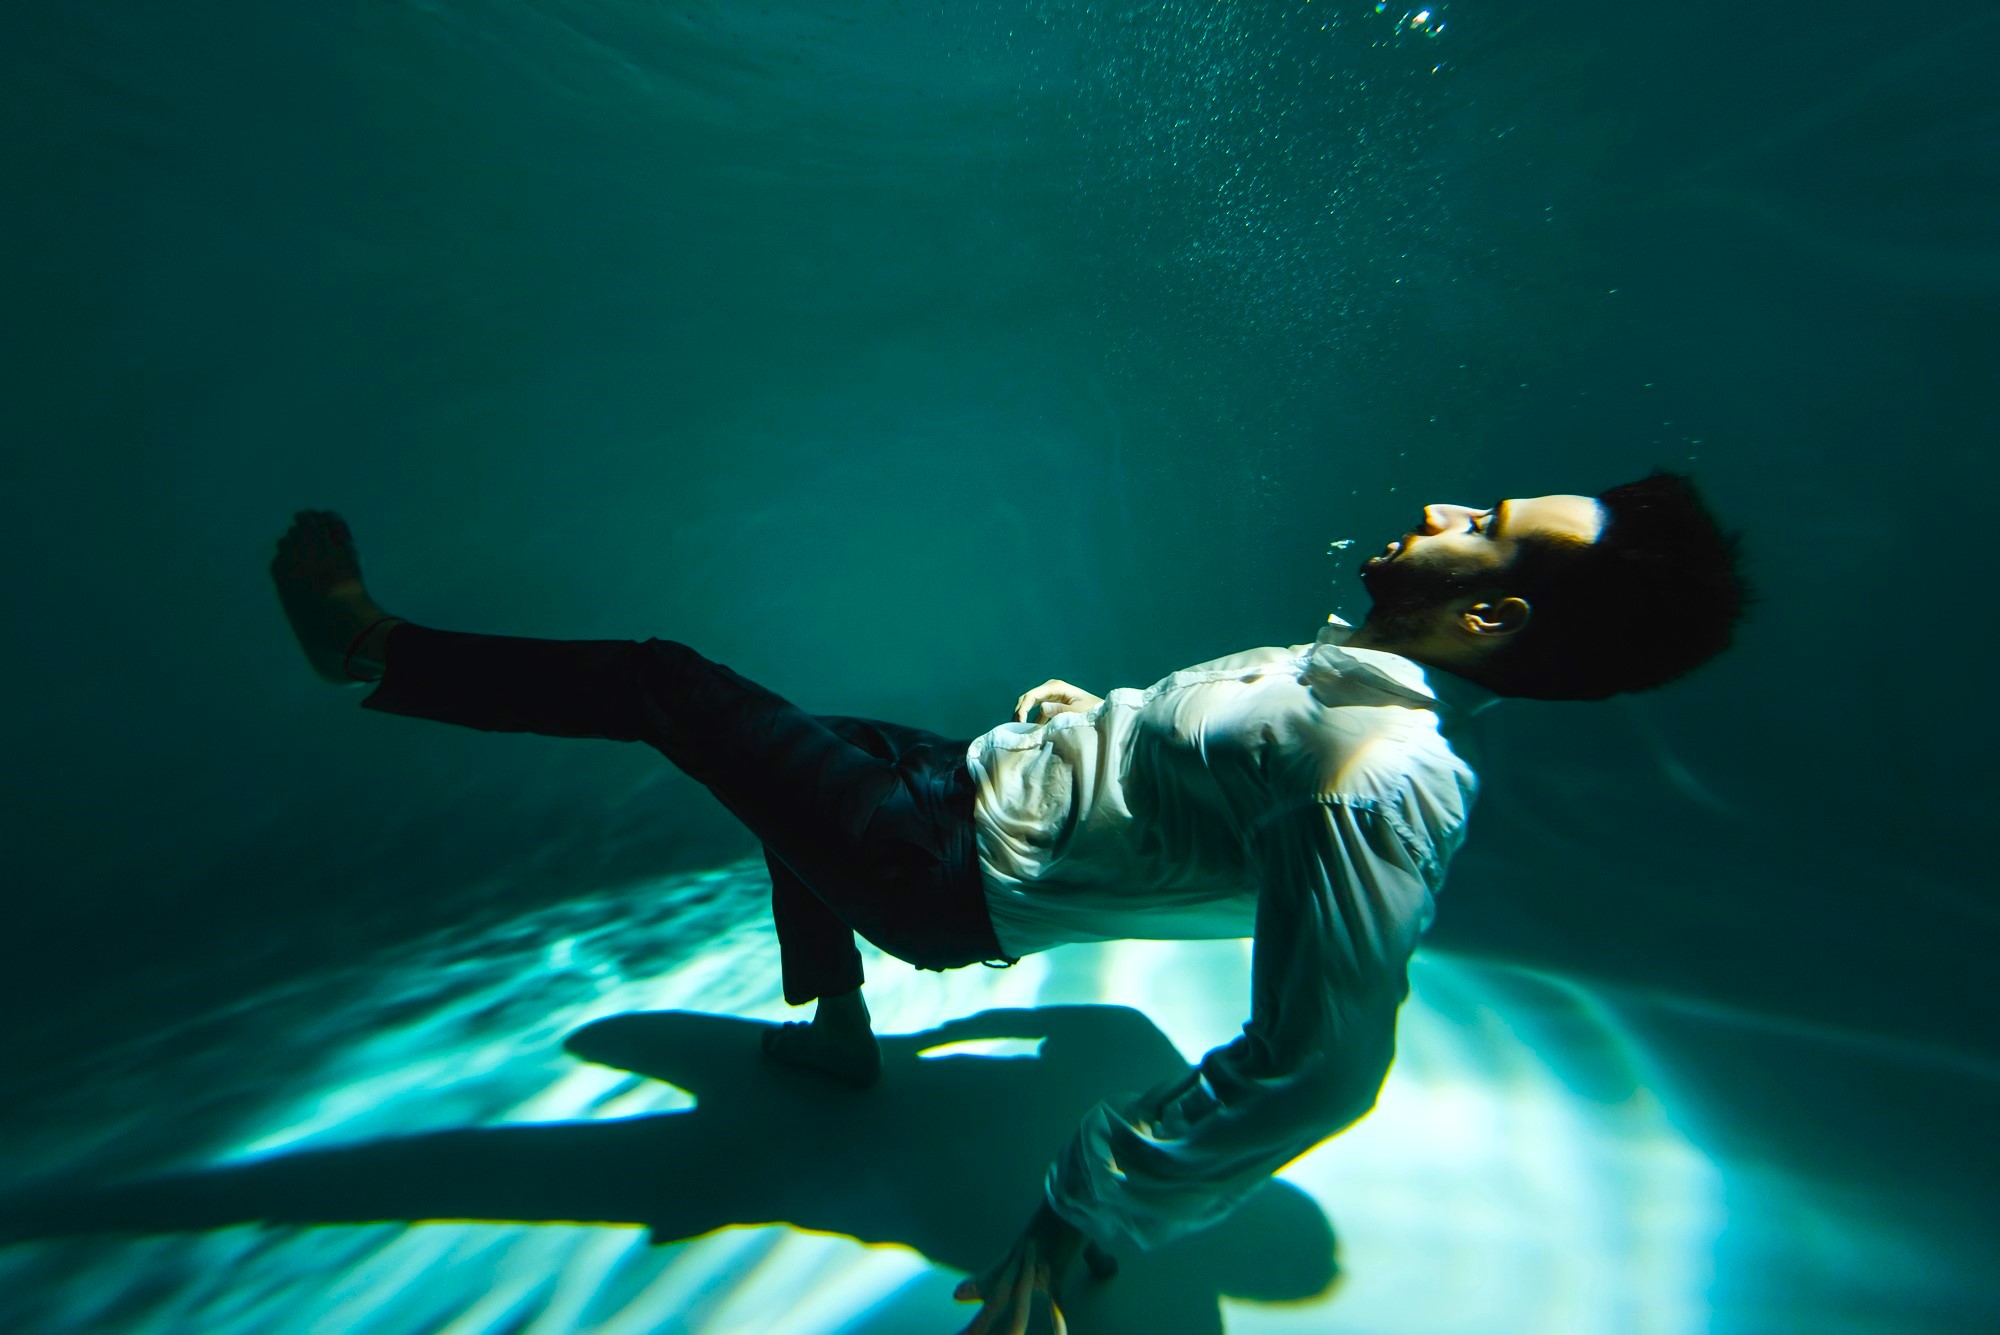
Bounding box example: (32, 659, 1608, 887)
(1360, 496, 1604, 614)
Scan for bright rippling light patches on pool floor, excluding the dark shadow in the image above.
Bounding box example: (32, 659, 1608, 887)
(0, 861, 1980, 1335)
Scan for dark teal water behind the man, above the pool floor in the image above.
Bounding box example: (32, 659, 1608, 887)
(0, 0, 2000, 1327)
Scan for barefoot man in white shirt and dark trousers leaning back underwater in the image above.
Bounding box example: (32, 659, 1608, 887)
(270, 472, 1750, 1335)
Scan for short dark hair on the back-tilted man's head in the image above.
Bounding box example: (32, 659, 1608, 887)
(1470, 468, 1756, 699)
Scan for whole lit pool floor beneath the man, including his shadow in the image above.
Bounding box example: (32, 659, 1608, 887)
(0, 861, 1996, 1335)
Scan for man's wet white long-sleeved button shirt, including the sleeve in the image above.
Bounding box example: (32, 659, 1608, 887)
(968, 618, 1496, 1249)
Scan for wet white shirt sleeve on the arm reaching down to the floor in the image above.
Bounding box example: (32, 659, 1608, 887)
(1044, 793, 1432, 1249)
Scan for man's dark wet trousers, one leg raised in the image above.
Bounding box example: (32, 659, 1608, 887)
(362, 622, 1004, 1005)
